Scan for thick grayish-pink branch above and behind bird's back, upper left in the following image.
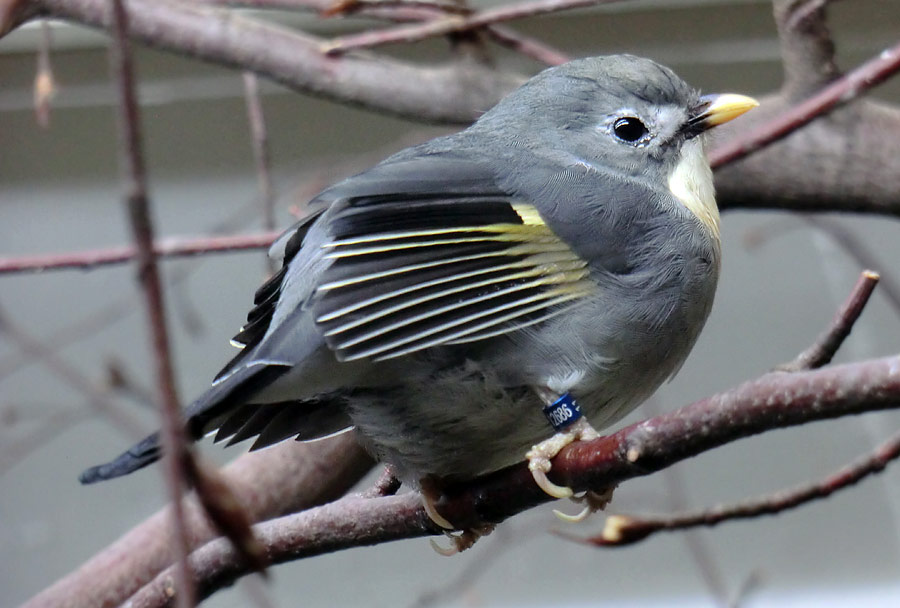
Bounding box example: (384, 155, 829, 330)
(30, 0, 524, 124)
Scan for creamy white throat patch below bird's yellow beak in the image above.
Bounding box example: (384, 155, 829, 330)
(669, 139, 719, 238)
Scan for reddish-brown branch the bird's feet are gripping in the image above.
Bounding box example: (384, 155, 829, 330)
(129, 356, 900, 608)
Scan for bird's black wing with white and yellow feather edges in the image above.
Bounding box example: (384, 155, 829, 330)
(313, 191, 594, 361)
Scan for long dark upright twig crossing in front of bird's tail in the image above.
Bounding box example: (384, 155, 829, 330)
(110, 0, 197, 608)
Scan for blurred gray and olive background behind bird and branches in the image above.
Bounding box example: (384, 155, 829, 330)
(0, 0, 900, 608)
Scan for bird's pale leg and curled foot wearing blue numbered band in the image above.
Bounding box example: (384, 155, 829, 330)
(525, 387, 600, 498)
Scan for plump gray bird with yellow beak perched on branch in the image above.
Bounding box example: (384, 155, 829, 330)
(81, 55, 757, 517)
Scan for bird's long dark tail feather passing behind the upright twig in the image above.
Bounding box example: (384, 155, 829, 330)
(78, 365, 290, 484)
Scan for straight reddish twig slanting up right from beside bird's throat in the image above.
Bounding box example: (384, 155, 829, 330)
(709, 43, 900, 169)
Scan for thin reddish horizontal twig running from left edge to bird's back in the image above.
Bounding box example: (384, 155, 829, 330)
(0, 230, 281, 274)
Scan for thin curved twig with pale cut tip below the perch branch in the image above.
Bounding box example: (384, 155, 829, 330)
(588, 434, 900, 547)
